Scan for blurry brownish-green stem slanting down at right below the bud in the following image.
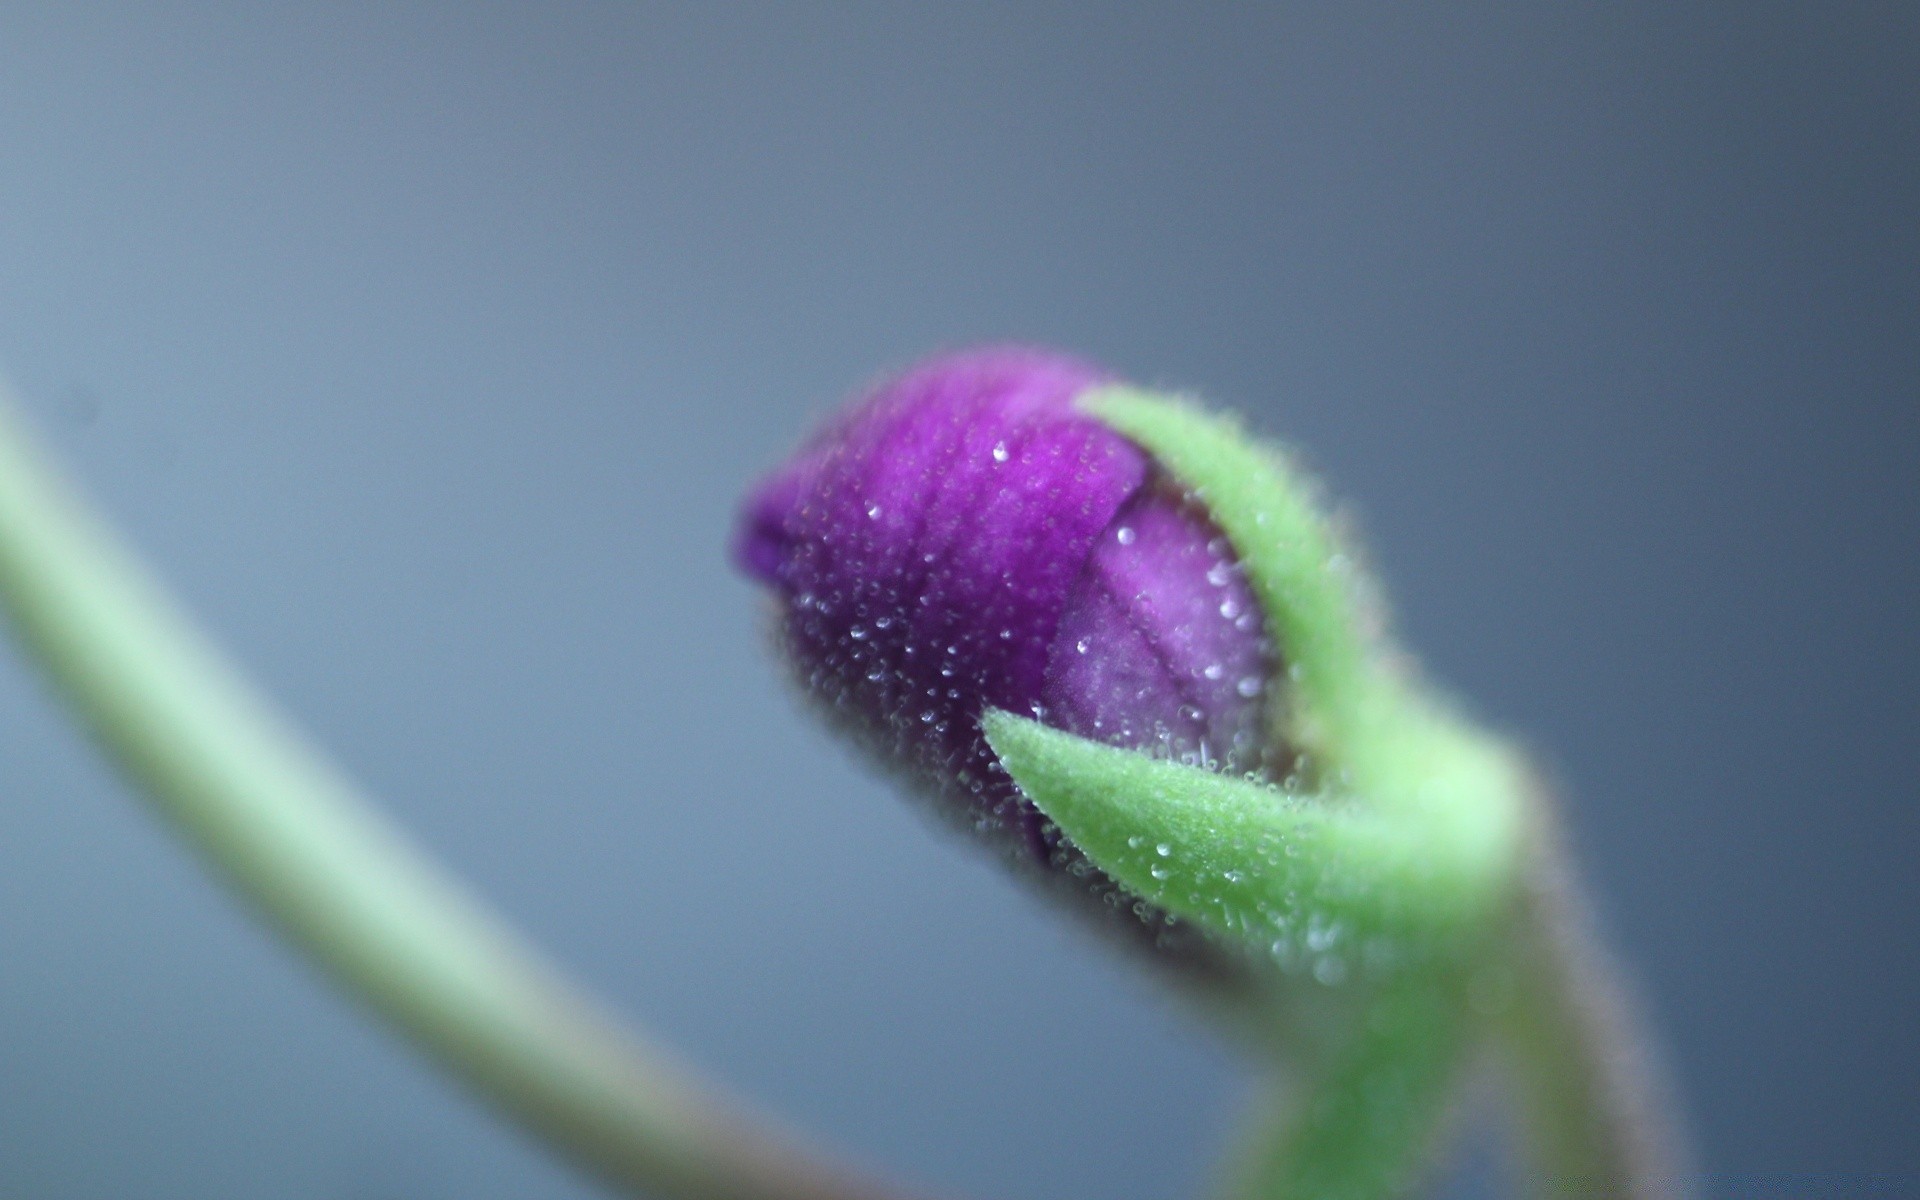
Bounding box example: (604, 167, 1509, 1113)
(1496, 799, 1692, 1200)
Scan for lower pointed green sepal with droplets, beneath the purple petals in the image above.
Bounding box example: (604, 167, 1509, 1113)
(981, 710, 1486, 963)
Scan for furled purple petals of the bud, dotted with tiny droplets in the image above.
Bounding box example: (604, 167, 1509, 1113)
(735, 348, 1273, 866)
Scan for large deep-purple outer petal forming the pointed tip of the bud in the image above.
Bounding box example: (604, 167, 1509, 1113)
(735, 348, 1146, 829)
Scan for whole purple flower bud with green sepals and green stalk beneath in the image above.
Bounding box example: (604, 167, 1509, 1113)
(733, 348, 1559, 1196)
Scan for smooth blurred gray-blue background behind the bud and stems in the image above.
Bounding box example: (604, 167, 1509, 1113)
(0, 9, 1920, 1200)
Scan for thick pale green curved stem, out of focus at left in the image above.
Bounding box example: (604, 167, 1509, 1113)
(0, 396, 936, 1200)
